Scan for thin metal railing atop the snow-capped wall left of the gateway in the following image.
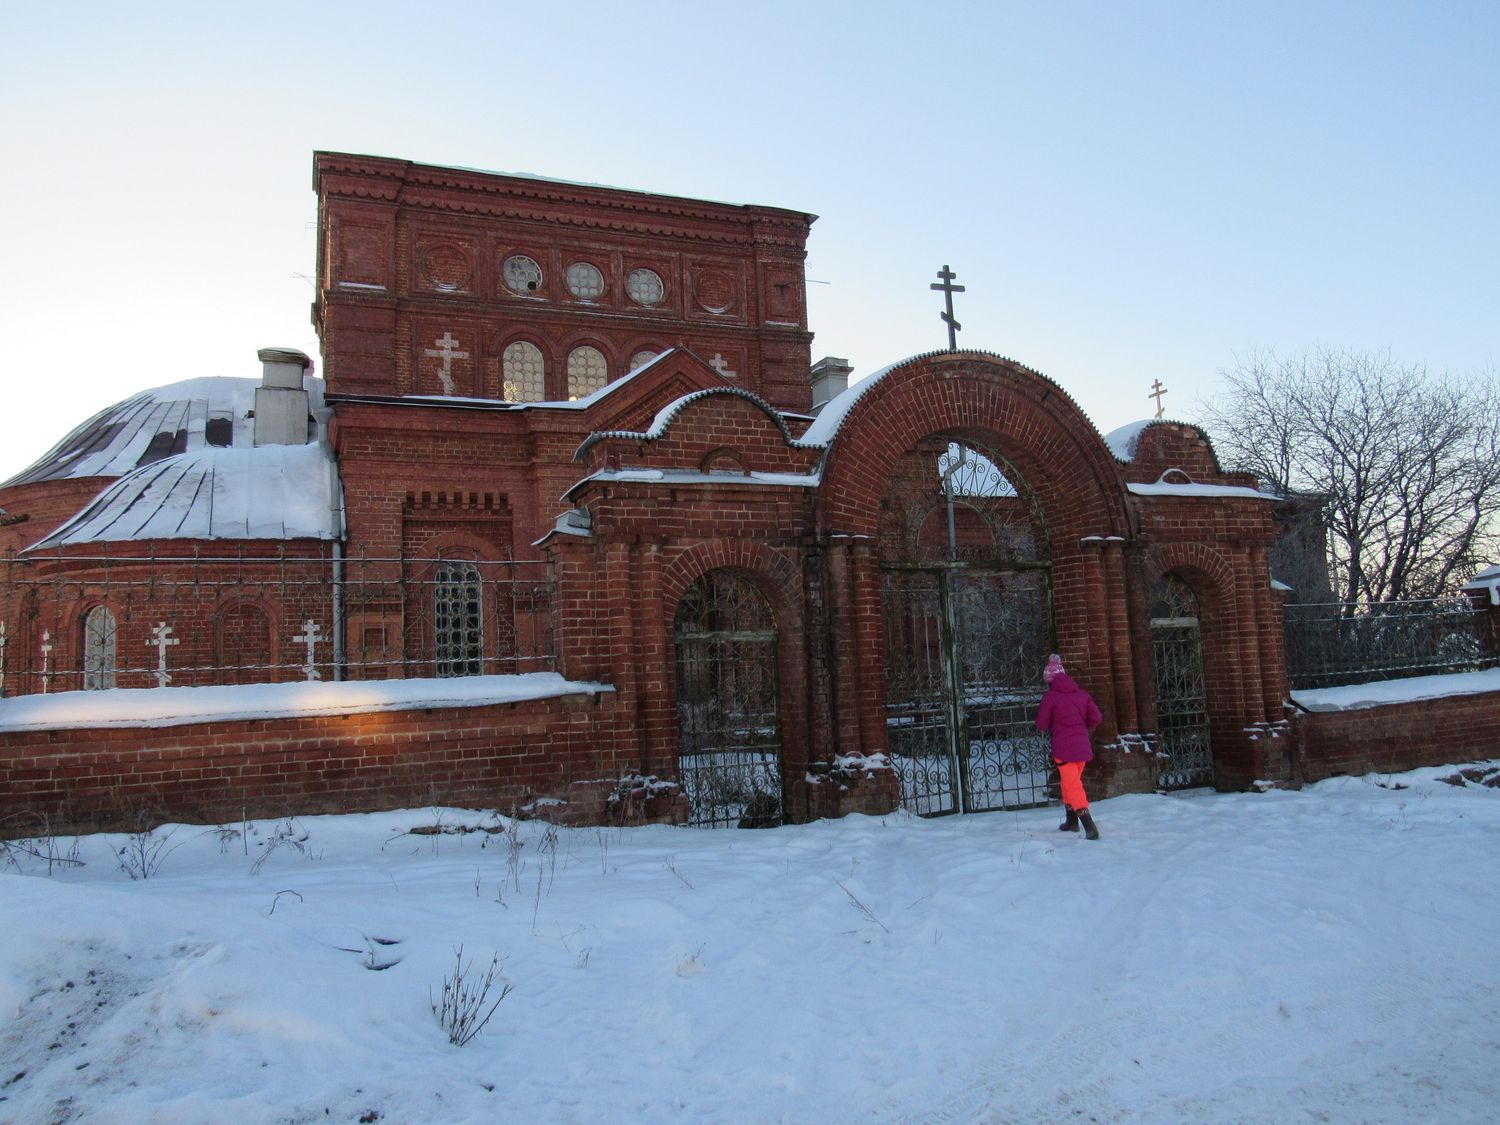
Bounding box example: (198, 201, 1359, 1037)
(0, 549, 557, 695)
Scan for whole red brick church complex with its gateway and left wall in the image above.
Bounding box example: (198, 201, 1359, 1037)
(0, 153, 1289, 825)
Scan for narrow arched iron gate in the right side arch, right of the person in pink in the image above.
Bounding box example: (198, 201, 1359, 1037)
(1151, 575, 1214, 789)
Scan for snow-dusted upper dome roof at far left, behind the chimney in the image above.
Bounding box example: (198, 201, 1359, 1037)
(0, 375, 324, 488)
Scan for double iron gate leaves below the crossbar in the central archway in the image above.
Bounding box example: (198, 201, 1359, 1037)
(885, 564, 1053, 816)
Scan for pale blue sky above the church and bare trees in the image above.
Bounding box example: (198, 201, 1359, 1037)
(0, 0, 1500, 479)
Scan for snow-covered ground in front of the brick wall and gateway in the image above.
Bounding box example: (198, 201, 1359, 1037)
(0, 762, 1500, 1125)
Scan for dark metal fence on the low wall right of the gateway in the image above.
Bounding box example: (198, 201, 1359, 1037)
(1286, 597, 1500, 689)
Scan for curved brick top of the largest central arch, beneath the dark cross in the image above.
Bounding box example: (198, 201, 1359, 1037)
(821, 354, 1131, 537)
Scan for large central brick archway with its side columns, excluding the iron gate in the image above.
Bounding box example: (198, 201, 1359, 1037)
(809, 353, 1136, 774)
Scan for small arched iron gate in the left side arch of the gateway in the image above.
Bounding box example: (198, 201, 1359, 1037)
(677, 570, 783, 828)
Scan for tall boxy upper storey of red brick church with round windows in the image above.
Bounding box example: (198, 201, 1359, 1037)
(314, 152, 815, 411)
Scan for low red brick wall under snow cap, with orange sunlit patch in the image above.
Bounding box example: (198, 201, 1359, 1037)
(0, 693, 633, 836)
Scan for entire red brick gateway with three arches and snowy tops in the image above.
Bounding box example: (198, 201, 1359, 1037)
(564, 353, 1283, 825)
